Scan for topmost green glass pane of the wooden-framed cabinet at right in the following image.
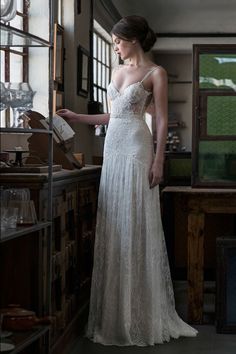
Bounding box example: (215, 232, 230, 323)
(199, 53, 236, 91)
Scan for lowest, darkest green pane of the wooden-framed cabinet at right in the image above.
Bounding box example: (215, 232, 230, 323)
(198, 141, 236, 182)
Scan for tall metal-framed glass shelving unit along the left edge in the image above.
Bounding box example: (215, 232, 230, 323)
(0, 0, 53, 354)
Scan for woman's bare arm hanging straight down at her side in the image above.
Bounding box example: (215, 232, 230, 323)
(149, 67, 168, 188)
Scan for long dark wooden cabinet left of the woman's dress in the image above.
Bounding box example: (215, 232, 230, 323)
(0, 166, 101, 354)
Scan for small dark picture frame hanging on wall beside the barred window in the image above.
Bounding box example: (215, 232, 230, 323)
(77, 46, 89, 97)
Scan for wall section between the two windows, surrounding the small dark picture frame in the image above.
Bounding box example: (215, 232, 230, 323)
(63, 0, 94, 163)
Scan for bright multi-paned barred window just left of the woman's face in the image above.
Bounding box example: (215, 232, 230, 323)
(93, 21, 111, 112)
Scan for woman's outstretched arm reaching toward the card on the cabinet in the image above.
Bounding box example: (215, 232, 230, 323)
(56, 109, 110, 125)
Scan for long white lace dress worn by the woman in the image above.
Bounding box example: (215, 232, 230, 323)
(86, 68, 197, 346)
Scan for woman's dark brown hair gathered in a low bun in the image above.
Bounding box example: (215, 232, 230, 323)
(111, 15, 156, 52)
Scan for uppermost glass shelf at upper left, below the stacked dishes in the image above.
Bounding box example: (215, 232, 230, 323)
(0, 23, 51, 49)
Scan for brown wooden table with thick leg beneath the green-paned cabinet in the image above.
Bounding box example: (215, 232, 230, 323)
(162, 186, 236, 324)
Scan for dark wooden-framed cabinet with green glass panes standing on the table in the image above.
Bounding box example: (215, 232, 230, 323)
(192, 44, 236, 188)
